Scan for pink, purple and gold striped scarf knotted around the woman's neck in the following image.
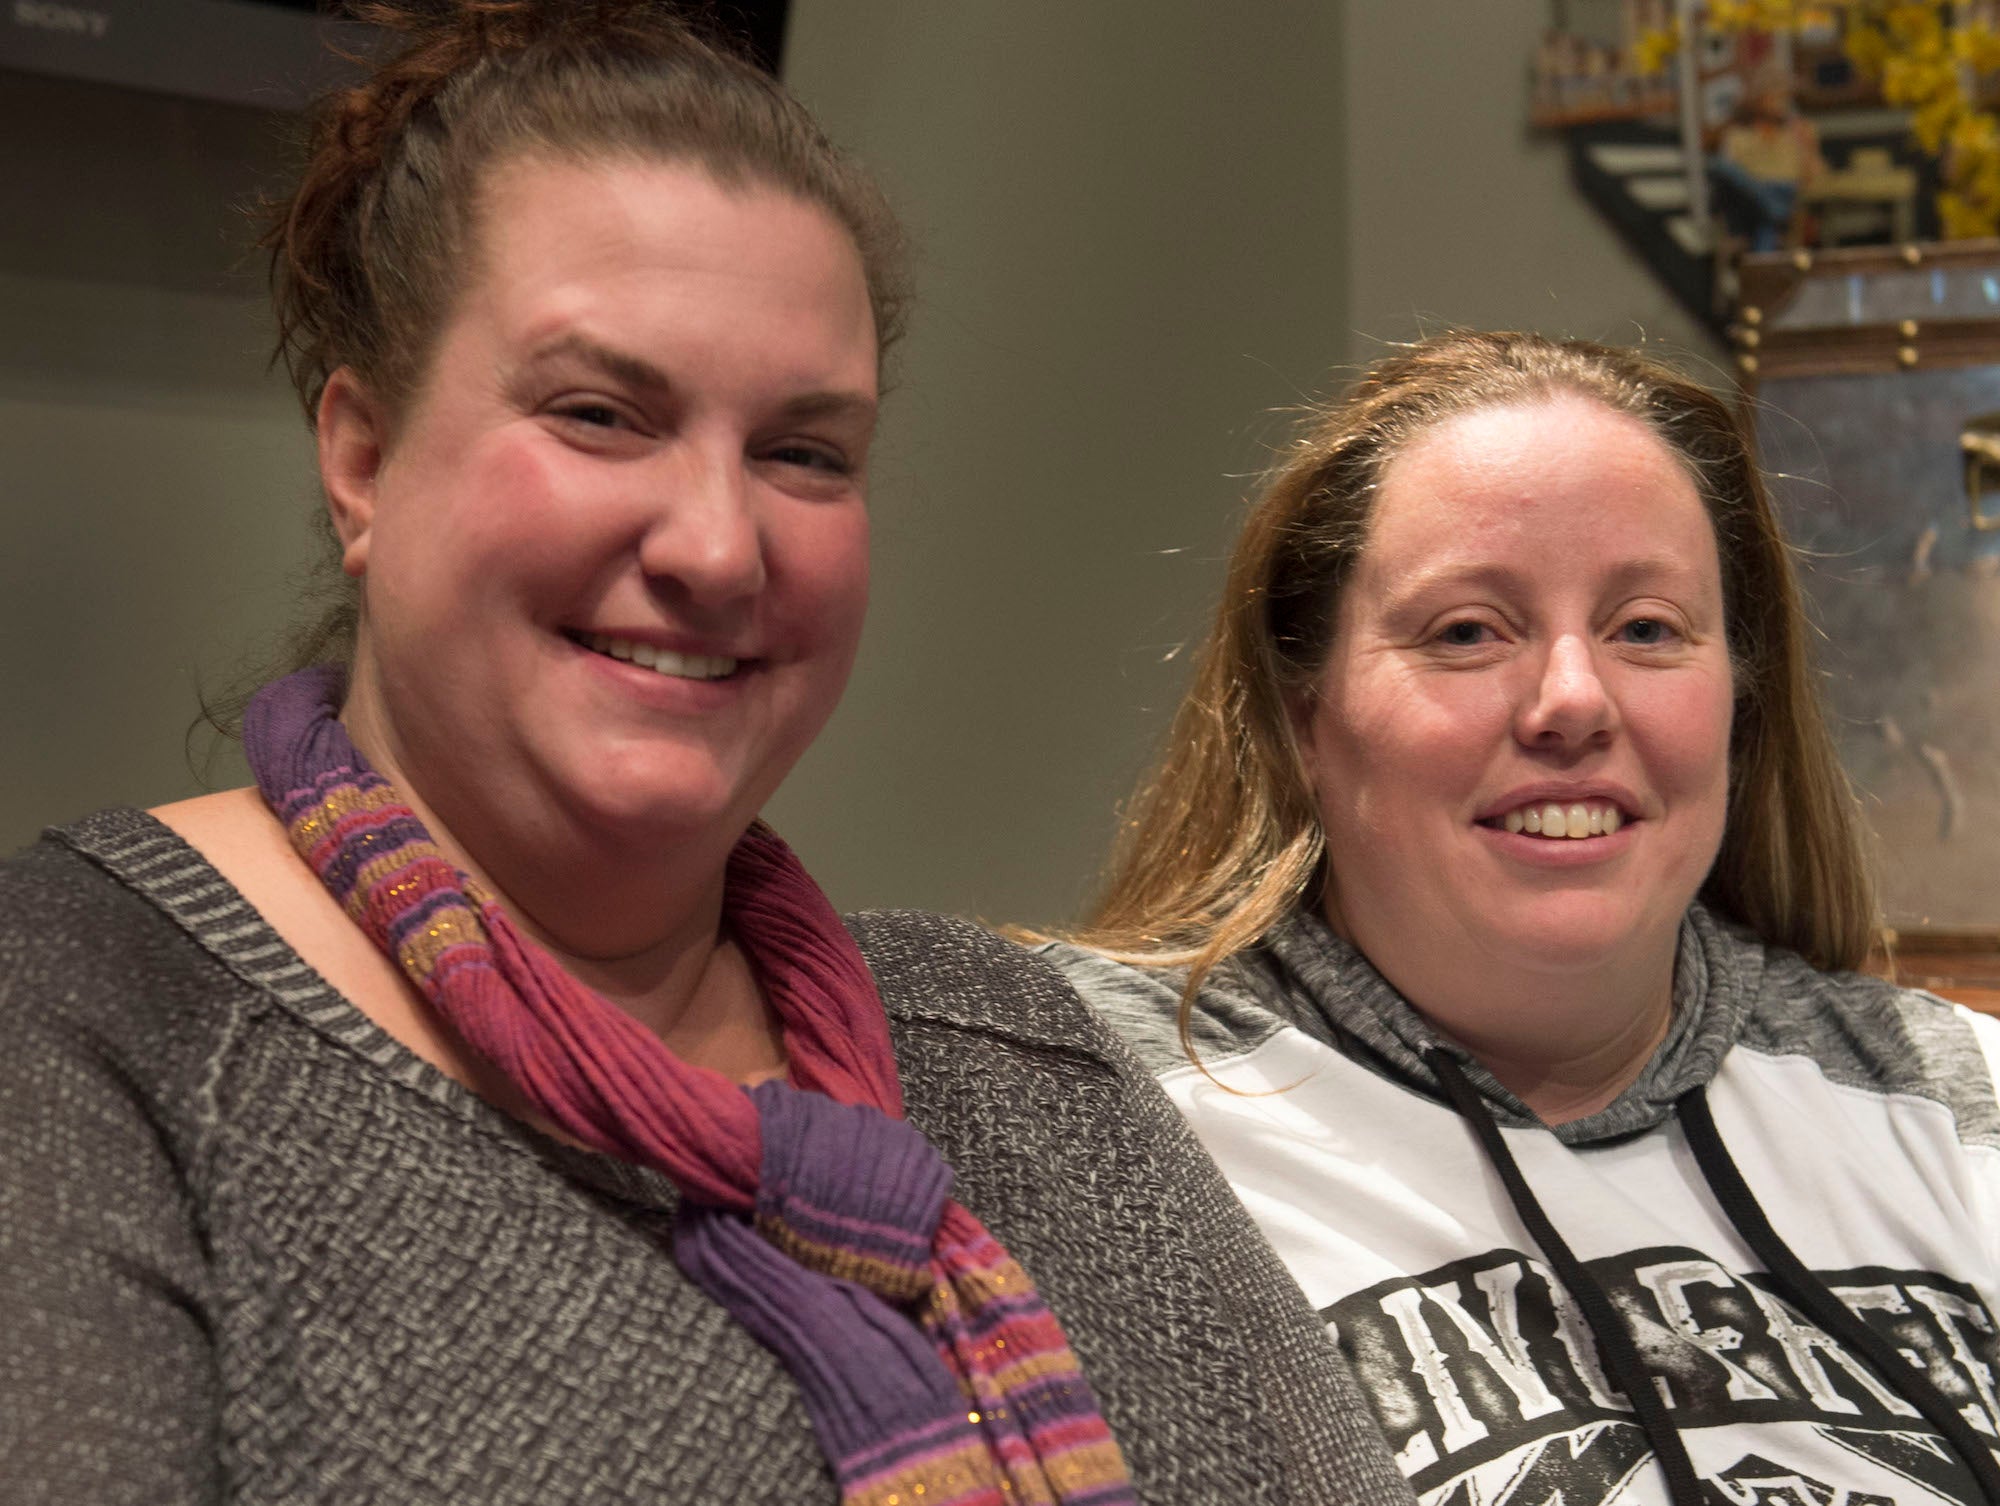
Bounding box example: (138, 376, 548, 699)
(244, 668, 1136, 1506)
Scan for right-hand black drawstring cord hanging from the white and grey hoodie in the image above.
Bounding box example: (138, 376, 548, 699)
(1676, 1088, 2000, 1506)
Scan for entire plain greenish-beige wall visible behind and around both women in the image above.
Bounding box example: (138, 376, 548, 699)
(0, 0, 1720, 920)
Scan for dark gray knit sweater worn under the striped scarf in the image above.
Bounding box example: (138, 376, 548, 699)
(0, 810, 1408, 1506)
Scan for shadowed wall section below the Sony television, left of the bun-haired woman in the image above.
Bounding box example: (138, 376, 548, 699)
(0, 74, 314, 852)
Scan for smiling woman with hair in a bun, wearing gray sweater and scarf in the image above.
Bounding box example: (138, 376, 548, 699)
(0, 0, 1406, 1506)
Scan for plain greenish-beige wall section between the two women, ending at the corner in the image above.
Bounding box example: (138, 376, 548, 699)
(774, 0, 1346, 920)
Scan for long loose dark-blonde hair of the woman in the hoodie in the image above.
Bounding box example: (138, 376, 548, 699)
(1072, 332, 1876, 1016)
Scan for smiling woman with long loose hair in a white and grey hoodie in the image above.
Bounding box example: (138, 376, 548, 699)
(1050, 332, 2000, 1506)
